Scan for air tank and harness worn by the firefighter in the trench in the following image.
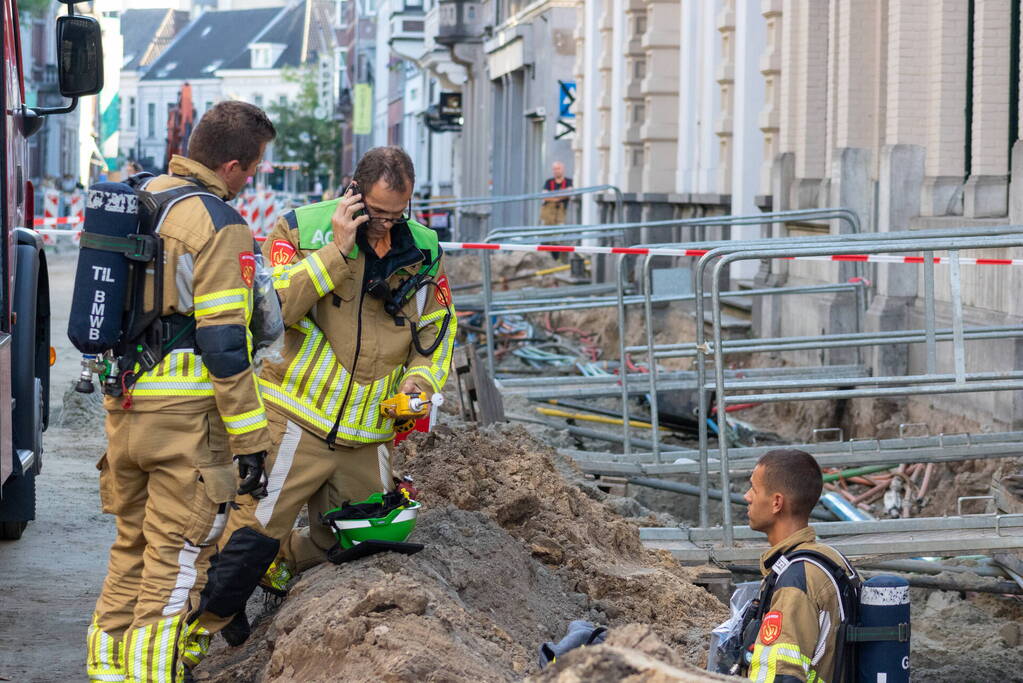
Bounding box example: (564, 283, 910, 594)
(713, 549, 909, 683)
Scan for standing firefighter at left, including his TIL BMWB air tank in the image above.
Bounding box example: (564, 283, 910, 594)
(68, 101, 282, 683)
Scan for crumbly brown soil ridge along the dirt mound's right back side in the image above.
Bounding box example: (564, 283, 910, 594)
(399, 425, 726, 662)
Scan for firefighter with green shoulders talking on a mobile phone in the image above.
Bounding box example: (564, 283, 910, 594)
(196, 147, 456, 644)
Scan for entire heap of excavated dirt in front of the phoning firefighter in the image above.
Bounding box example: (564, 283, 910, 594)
(197, 426, 725, 682)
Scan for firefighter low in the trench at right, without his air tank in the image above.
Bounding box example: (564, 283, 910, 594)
(745, 449, 856, 683)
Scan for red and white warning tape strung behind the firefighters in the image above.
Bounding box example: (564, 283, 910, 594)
(24, 232, 1023, 266)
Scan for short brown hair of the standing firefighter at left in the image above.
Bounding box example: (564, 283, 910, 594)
(188, 100, 277, 171)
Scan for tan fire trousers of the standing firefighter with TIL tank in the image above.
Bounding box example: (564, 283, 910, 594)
(88, 410, 237, 681)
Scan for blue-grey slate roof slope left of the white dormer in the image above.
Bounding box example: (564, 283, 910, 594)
(142, 7, 287, 81)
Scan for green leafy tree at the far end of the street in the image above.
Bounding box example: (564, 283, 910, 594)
(267, 67, 343, 188)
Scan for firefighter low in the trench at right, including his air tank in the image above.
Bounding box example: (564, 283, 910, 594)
(708, 449, 909, 683)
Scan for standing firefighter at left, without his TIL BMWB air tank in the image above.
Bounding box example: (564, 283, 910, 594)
(87, 102, 275, 683)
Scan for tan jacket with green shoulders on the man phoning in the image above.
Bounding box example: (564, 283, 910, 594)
(260, 200, 456, 444)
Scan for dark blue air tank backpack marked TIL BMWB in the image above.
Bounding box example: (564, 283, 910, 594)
(68, 173, 283, 396)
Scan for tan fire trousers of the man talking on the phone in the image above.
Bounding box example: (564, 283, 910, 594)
(198, 405, 393, 632)
